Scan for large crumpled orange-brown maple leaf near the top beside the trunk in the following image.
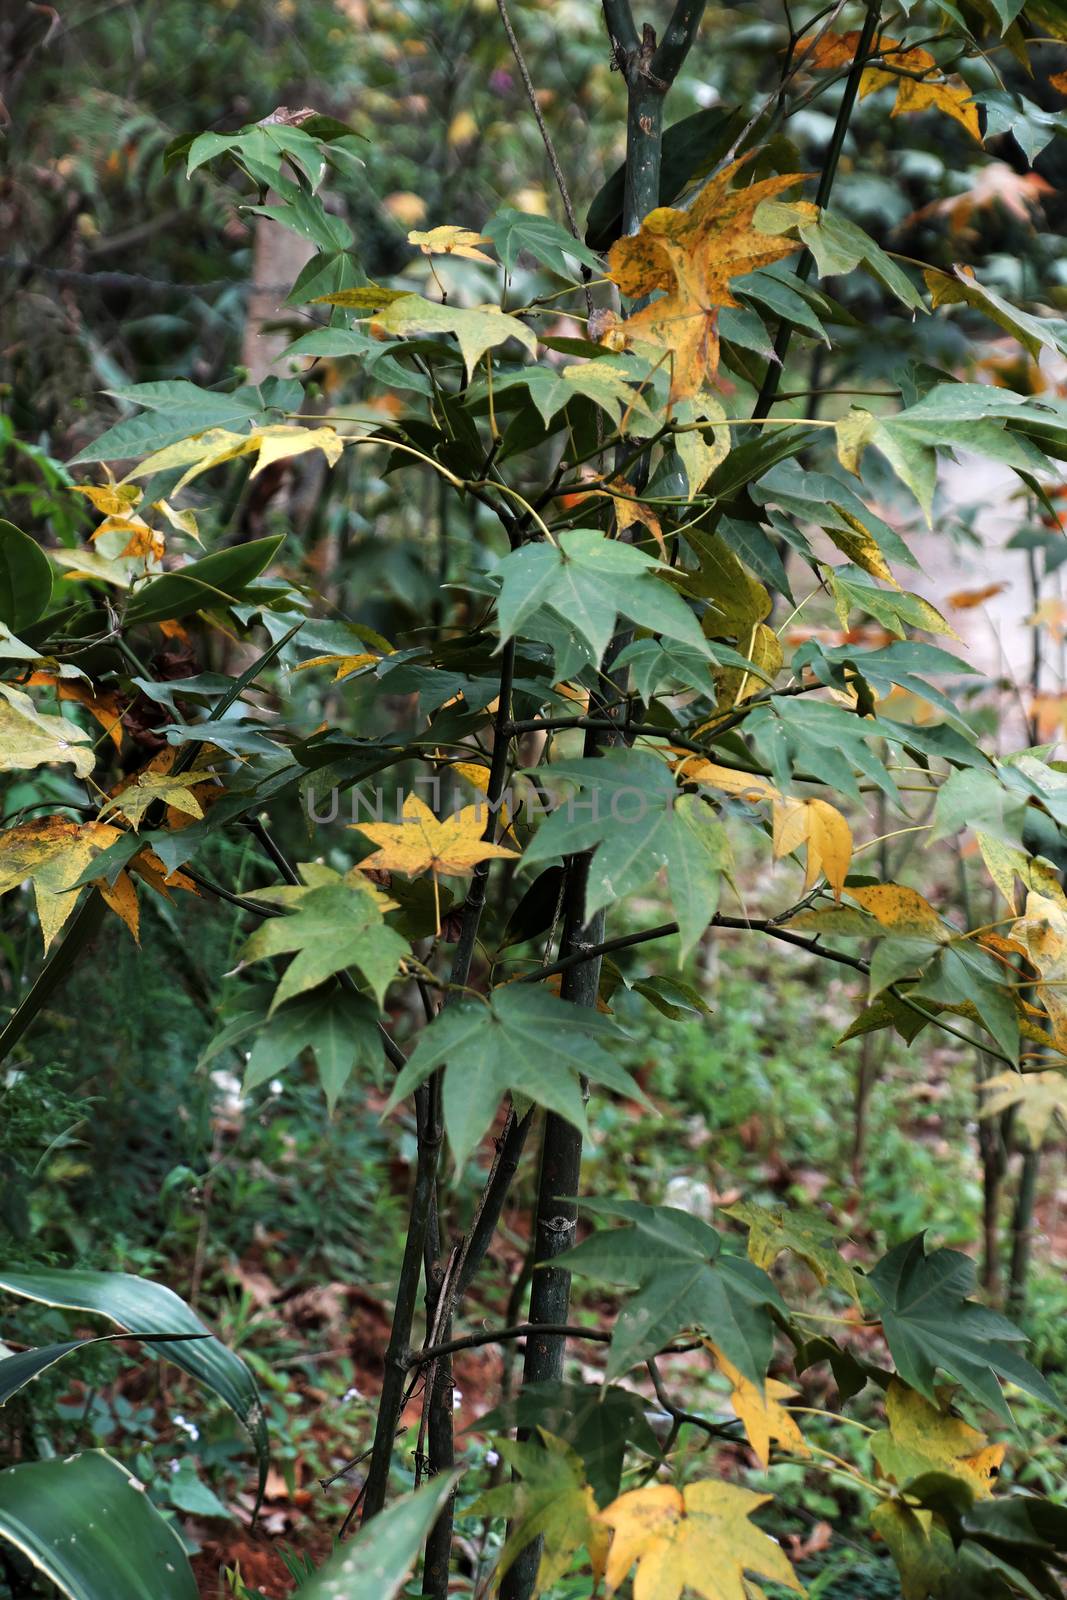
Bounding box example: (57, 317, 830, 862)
(608, 157, 806, 402)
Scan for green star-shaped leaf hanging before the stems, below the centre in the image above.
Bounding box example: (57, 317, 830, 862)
(386, 982, 643, 1168)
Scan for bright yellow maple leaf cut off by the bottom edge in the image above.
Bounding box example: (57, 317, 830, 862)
(600, 1480, 803, 1600)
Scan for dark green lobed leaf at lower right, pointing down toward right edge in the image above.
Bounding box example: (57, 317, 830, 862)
(867, 1234, 1062, 1419)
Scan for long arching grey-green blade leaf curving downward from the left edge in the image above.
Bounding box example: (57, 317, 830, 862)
(0, 1267, 267, 1494)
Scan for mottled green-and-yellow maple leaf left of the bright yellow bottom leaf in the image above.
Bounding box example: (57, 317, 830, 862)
(464, 1427, 609, 1594)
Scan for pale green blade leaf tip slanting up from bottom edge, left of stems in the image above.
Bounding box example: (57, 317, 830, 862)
(301, 1472, 462, 1600)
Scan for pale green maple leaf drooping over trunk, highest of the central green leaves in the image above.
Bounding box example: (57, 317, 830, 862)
(496, 528, 710, 661)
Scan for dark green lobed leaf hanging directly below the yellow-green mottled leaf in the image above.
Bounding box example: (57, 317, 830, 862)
(243, 989, 382, 1114)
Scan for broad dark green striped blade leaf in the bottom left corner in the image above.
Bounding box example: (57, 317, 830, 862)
(0, 1450, 197, 1600)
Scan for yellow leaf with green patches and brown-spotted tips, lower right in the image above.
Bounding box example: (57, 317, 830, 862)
(870, 1378, 1005, 1499)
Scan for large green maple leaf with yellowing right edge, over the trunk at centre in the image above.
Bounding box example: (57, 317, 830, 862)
(523, 750, 733, 962)
